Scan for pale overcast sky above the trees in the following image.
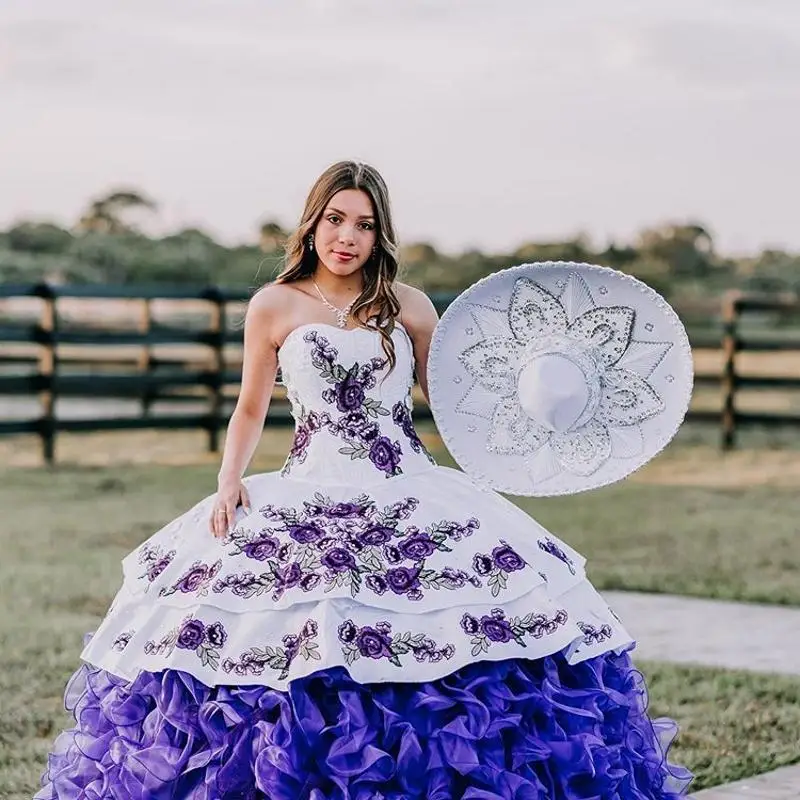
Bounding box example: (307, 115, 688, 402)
(0, 0, 800, 253)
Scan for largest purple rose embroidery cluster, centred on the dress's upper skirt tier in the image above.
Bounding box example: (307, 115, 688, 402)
(212, 493, 484, 601)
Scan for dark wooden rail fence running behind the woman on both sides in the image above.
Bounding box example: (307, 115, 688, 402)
(0, 284, 800, 463)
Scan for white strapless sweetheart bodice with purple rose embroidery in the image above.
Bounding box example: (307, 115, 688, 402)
(279, 323, 435, 485)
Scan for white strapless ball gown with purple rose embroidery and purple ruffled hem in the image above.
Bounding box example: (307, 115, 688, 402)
(36, 324, 690, 800)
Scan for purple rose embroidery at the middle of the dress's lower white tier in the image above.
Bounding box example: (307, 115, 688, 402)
(338, 619, 455, 667)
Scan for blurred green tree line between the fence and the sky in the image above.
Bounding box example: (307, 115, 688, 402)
(0, 189, 800, 305)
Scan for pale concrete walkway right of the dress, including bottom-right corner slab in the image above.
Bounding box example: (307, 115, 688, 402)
(602, 592, 800, 800)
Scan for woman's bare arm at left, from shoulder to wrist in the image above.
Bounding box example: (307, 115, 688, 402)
(219, 286, 279, 487)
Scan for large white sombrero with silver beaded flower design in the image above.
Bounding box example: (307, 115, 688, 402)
(428, 262, 693, 496)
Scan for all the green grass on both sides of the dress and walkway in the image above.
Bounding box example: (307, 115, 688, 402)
(0, 456, 800, 800)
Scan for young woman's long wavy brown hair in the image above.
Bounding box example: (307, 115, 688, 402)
(275, 161, 400, 370)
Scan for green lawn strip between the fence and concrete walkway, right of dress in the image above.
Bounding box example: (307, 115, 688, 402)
(428, 444, 800, 605)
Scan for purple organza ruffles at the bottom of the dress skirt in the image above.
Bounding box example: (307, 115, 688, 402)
(36, 653, 691, 800)
